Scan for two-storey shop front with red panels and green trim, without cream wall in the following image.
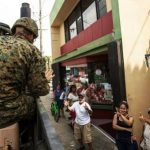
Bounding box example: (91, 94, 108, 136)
(51, 0, 126, 138)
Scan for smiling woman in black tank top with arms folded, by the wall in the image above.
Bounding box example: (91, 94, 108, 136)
(113, 101, 135, 150)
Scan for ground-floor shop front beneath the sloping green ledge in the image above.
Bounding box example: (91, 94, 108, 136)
(51, 41, 126, 136)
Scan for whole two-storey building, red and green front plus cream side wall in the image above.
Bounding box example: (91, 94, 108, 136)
(50, 0, 150, 141)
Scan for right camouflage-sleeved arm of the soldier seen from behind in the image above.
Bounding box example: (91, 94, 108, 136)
(28, 50, 50, 96)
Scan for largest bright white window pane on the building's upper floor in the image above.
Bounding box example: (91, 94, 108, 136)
(82, 2, 97, 29)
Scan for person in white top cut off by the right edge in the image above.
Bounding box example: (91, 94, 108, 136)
(139, 108, 150, 150)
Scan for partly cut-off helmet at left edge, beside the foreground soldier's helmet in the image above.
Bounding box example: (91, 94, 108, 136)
(0, 22, 11, 36)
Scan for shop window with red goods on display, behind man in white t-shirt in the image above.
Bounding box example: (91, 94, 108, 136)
(89, 62, 113, 105)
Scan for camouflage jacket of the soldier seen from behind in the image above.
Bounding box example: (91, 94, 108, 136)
(0, 36, 49, 128)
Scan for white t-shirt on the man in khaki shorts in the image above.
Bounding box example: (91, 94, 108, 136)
(71, 101, 91, 125)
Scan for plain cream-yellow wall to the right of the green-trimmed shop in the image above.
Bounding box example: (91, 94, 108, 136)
(118, 0, 150, 140)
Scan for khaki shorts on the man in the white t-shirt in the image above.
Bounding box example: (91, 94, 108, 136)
(74, 123, 92, 143)
